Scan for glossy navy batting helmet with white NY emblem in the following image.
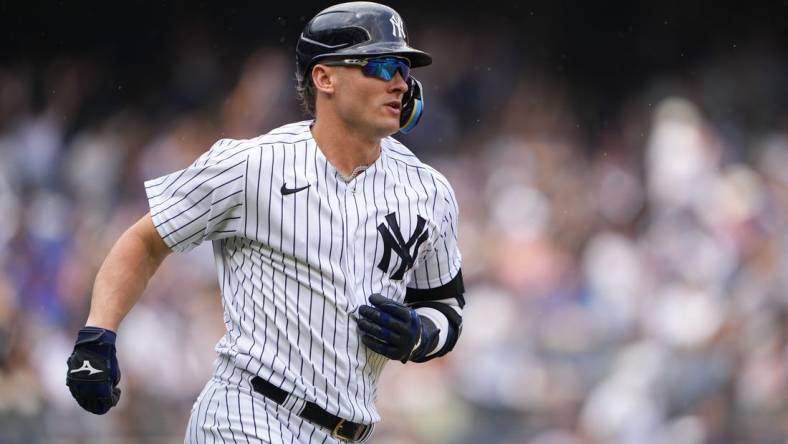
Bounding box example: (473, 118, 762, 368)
(296, 2, 432, 86)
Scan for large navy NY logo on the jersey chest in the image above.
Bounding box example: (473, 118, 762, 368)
(378, 212, 429, 280)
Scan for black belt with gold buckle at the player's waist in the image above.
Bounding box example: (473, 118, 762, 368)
(252, 376, 372, 442)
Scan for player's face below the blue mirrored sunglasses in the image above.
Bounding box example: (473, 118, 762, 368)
(335, 59, 408, 138)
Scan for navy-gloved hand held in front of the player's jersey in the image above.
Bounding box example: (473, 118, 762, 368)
(358, 294, 438, 363)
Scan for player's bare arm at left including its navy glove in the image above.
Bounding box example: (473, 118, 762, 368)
(66, 214, 170, 415)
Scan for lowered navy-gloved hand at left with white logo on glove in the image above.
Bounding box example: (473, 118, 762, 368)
(66, 327, 120, 415)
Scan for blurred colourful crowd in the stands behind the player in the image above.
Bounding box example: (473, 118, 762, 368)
(0, 19, 788, 444)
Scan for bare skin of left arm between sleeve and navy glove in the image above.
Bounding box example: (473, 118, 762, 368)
(86, 215, 169, 331)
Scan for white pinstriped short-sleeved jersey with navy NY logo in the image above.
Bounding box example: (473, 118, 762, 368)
(145, 121, 461, 423)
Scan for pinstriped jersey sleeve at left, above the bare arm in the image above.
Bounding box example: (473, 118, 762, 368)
(145, 139, 248, 251)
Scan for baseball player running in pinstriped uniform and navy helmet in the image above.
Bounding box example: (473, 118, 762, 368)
(67, 2, 464, 443)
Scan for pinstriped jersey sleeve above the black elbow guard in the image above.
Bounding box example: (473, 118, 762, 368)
(407, 177, 462, 289)
